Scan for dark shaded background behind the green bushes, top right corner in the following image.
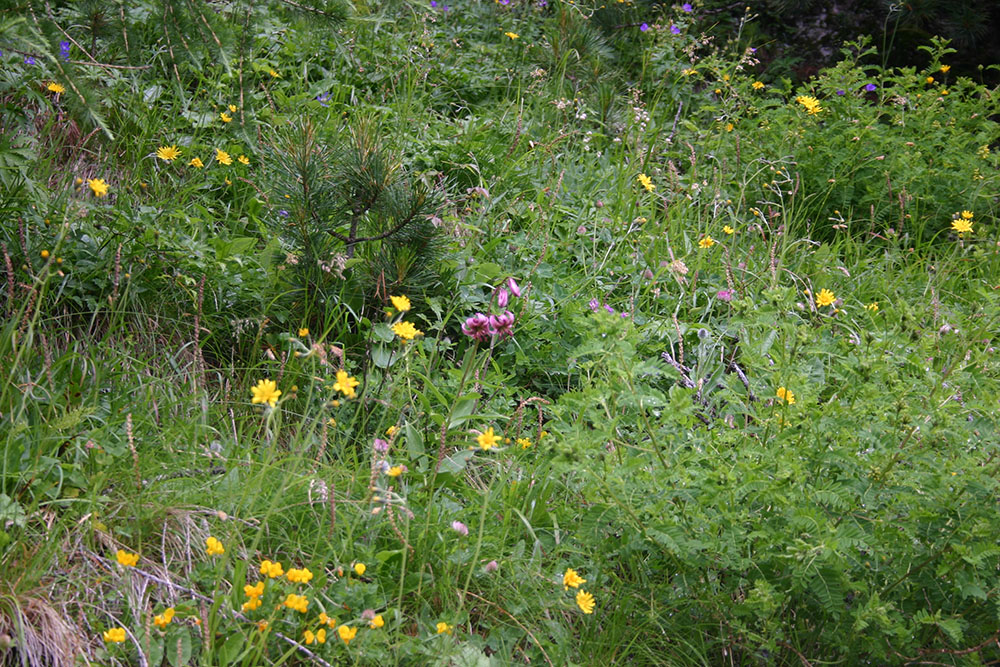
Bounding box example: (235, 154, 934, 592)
(696, 0, 1000, 85)
